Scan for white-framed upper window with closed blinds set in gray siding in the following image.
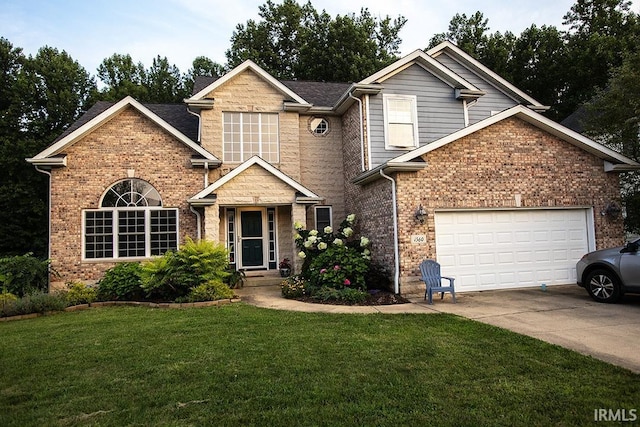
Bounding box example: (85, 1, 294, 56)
(382, 94, 418, 150)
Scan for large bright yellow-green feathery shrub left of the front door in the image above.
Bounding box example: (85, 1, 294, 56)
(141, 239, 230, 301)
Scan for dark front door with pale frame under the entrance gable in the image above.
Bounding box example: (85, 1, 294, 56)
(240, 210, 266, 268)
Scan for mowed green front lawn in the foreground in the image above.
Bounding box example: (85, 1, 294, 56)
(0, 304, 640, 426)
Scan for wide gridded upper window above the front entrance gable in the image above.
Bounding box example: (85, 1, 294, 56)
(222, 113, 279, 163)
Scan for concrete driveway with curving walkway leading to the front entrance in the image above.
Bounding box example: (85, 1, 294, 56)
(236, 285, 640, 373)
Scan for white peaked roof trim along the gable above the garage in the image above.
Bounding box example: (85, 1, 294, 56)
(389, 105, 640, 169)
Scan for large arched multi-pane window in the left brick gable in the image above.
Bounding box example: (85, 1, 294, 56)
(83, 178, 178, 259)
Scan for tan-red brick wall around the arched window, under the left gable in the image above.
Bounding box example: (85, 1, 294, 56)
(51, 107, 203, 288)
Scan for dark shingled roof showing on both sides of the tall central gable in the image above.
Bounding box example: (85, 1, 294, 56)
(193, 76, 351, 107)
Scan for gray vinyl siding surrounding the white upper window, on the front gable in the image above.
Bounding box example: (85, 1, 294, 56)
(369, 65, 464, 167)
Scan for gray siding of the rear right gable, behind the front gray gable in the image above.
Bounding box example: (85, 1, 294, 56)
(435, 53, 518, 125)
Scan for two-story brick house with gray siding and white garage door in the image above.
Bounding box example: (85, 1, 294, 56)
(28, 42, 640, 293)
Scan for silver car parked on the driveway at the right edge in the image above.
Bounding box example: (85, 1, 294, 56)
(576, 239, 640, 302)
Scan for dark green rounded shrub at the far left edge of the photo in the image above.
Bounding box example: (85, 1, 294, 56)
(0, 253, 50, 297)
